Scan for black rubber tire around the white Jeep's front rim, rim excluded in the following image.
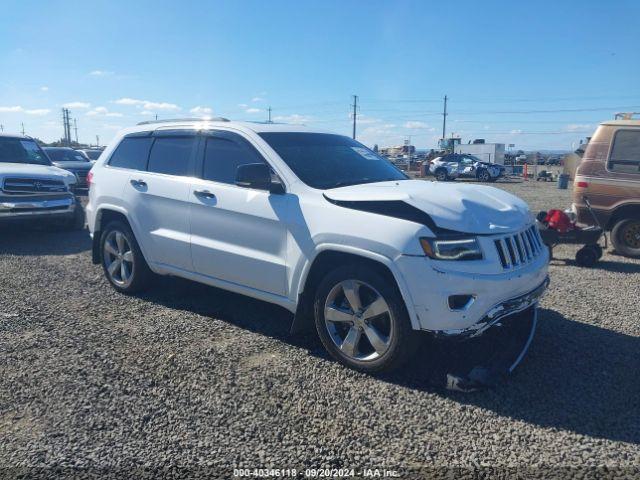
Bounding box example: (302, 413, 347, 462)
(314, 265, 416, 373)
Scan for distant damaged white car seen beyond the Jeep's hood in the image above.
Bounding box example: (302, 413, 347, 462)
(429, 153, 505, 182)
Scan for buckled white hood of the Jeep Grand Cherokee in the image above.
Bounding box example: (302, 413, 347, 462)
(324, 180, 531, 235)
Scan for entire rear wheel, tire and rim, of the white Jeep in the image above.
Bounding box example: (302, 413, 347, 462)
(100, 221, 152, 294)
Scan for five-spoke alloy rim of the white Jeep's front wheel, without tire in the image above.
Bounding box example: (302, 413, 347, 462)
(324, 280, 395, 361)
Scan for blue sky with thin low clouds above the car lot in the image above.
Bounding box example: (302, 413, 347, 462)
(0, 0, 640, 149)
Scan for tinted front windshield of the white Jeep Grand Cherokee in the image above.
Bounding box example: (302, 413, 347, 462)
(260, 132, 407, 190)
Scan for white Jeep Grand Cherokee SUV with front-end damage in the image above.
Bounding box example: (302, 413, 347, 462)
(87, 119, 548, 372)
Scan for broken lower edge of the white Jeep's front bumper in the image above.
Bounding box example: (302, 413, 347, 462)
(433, 277, 549, 340)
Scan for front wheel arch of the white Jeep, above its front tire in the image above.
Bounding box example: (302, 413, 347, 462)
(291, 245, 420, 333)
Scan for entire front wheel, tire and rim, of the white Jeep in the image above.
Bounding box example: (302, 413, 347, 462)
(314, 265, 417, 373)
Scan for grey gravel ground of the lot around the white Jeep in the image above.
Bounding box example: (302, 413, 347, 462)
(0, 182, 640, 478)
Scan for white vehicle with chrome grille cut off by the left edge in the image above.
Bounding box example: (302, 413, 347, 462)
(0, 133, 84, 229)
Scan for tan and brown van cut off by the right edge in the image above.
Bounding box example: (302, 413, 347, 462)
(572, 119, 640, 258)
